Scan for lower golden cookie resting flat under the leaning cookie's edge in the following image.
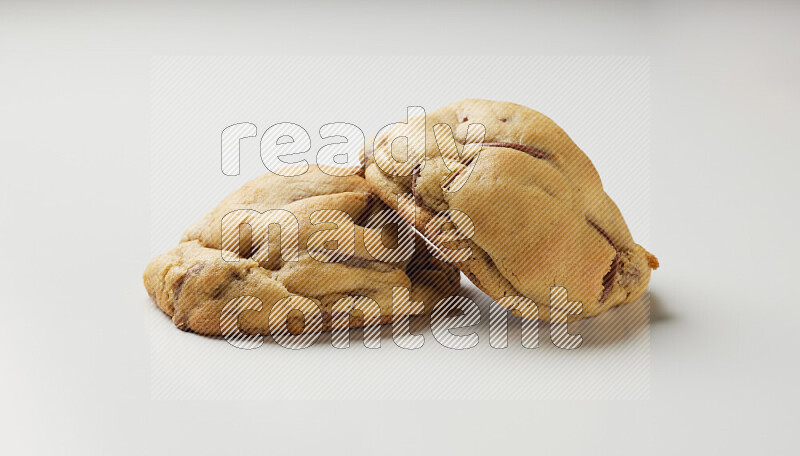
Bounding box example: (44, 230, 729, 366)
(144, 165, 459, 335)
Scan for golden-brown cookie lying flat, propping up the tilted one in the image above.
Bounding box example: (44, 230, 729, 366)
(144, 165, 459, 335)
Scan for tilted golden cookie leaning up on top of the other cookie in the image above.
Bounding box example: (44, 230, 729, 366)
(365, 100, 658, 320)
